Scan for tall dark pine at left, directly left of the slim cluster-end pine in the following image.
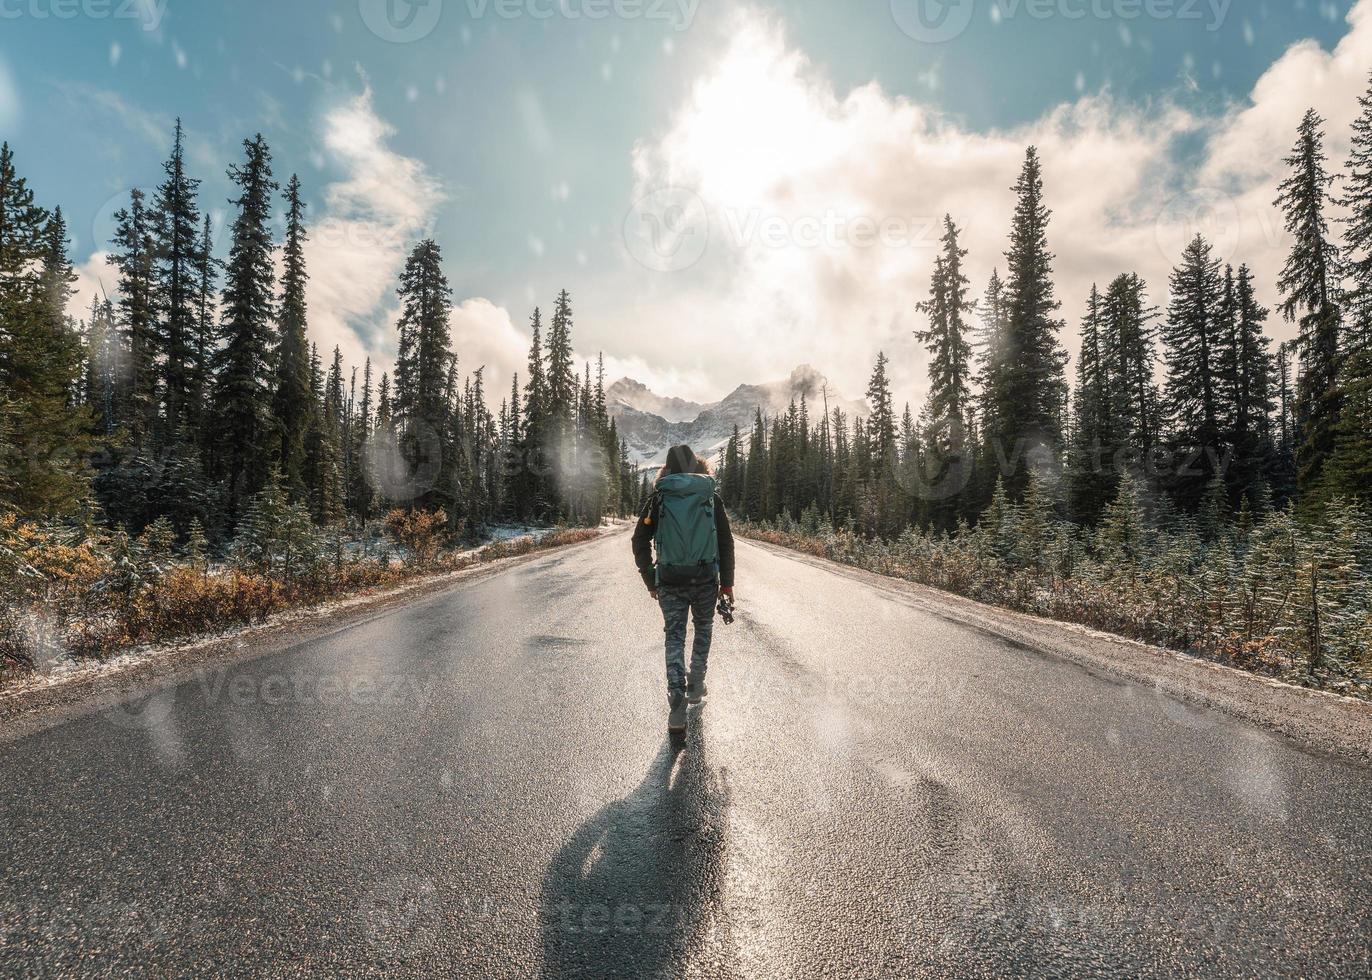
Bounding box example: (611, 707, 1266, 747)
(215, 135, 277, 523)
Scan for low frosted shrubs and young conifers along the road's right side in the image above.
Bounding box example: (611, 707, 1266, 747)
(737, 476, 1372, 697)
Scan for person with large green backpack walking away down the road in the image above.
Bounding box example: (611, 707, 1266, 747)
(634, 446, 734, 737)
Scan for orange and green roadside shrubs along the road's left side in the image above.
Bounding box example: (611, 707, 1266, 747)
(0, 496, 598, 681)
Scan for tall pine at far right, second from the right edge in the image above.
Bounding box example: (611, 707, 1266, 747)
(1276, 108, 1342, 504)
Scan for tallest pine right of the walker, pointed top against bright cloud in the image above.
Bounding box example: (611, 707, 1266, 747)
(988, 147, 1067, 498)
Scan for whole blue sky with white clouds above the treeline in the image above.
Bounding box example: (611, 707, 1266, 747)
(0, 0, 1372, 398)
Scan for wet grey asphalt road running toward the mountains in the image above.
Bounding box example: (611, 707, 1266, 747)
(0, 535, 1372, 977)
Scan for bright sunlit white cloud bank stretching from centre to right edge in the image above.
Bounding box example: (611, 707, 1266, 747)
(620, 0, 1372, 404)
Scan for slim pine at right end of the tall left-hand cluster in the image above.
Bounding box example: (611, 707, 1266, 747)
(272, 176, 314, 500)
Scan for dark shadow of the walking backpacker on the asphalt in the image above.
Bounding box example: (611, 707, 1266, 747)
(541, 712, 730, 977)
